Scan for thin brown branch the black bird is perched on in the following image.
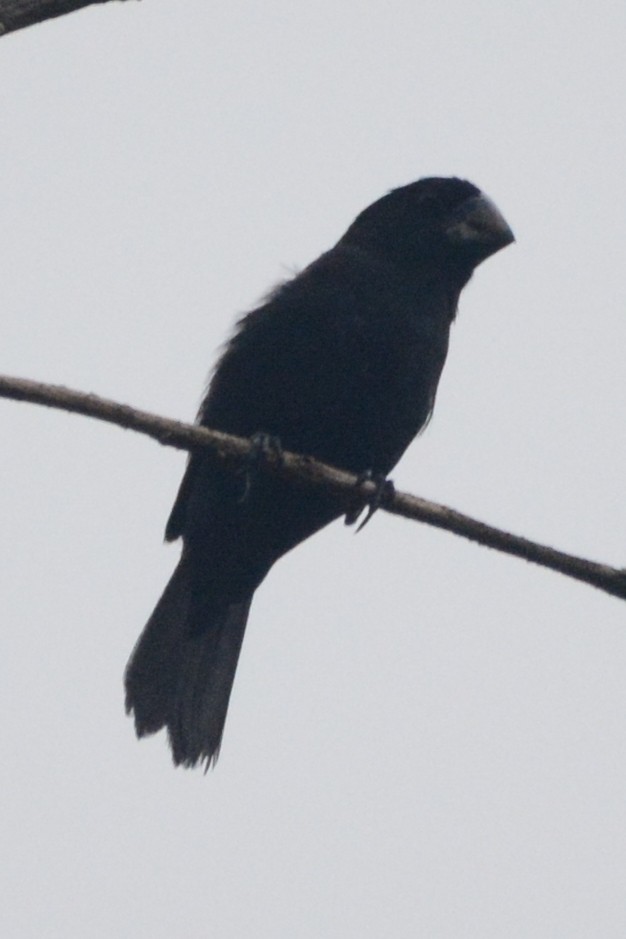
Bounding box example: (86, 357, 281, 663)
(0, 376, 626, 599)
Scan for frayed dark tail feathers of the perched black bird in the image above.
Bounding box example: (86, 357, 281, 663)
(125, 553, 252, 768)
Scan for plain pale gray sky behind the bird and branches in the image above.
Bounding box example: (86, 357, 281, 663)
(0, 0, 626, 939)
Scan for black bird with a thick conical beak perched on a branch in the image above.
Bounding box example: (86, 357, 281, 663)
(126, 178, 513, 766)
